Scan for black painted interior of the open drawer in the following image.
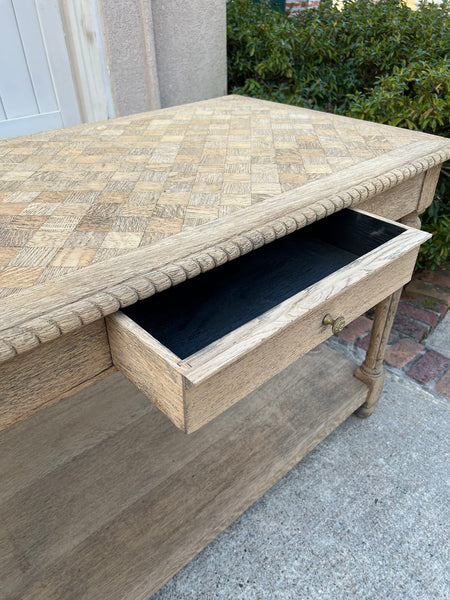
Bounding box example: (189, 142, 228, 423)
(123, 210, 404, 359)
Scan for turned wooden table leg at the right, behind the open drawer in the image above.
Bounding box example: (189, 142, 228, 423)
(355, 211, 421, 418)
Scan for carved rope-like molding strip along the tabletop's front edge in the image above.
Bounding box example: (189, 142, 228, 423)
(0, 148, 450, 363)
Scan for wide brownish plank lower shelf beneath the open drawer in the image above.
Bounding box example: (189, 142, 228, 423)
(0, 346, 367, 600)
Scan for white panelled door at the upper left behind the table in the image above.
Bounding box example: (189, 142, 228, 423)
(0, 0, 81, 138)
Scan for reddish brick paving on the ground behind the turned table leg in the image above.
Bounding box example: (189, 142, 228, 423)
(339, 268, 450, 398)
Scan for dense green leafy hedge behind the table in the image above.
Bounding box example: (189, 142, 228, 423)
(227, 0, 450, 268)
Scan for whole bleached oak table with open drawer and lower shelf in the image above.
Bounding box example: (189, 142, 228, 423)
(0, 96, 450, 600)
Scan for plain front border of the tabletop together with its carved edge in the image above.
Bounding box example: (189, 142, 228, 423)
(0, 134, 450, 363)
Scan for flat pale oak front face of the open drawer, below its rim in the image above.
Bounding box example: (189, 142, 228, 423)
(185, 248, 416, 432)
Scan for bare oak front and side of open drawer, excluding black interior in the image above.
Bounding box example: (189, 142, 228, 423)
(106, 211, 429, 433)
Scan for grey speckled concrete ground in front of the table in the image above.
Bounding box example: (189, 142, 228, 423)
(152, 344, 450, 600)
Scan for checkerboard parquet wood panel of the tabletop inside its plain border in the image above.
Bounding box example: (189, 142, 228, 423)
(0, 96, 420, 297)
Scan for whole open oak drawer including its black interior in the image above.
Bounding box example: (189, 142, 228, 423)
(106, 210, 430, 433)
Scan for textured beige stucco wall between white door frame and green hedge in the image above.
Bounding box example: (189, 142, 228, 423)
(97, 0, 227, 115)
